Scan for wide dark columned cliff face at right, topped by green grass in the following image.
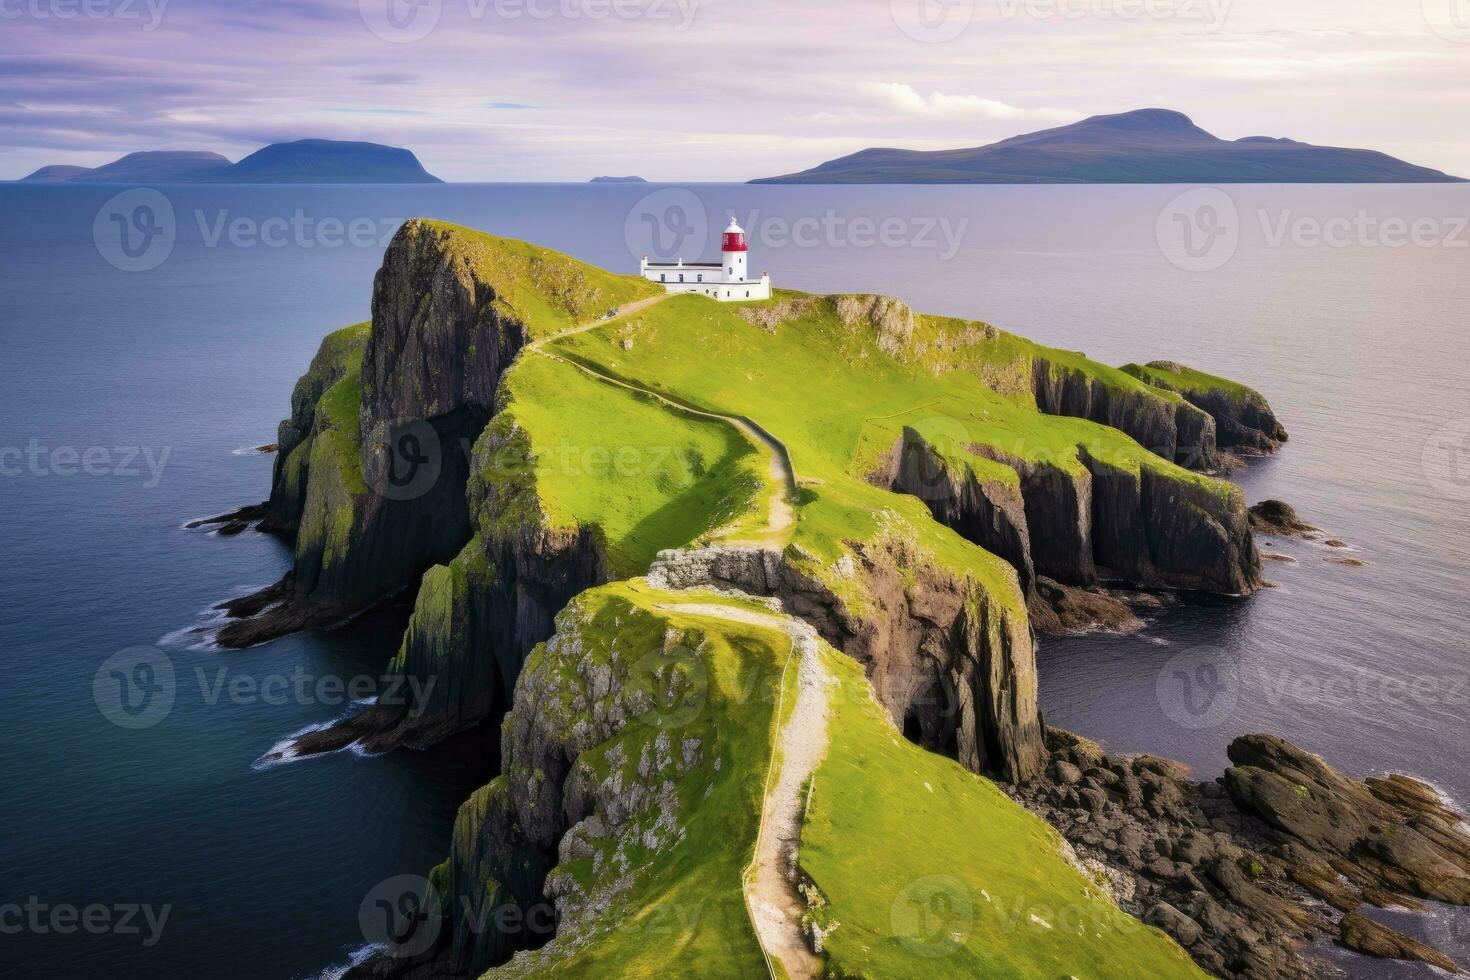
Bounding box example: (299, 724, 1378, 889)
(875, 429, 1261, 601)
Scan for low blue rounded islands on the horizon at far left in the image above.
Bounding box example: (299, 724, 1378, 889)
(21, 140, 442, 184)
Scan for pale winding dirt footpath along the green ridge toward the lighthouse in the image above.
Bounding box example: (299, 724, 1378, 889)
(546, 294, 832, 980)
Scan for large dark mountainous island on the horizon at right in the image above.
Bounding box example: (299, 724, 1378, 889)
(751, 109, 1463, 184)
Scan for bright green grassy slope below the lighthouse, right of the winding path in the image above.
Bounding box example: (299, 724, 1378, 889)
(540, 285, 1239, 597)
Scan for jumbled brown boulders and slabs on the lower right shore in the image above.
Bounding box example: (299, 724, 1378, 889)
(1011, 729, 1470, 977)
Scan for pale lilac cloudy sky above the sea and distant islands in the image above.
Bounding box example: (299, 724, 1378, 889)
(0, 0, 1470, 181)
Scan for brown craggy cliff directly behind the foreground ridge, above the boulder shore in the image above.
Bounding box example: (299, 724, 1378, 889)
(648, 542, 1044, 782)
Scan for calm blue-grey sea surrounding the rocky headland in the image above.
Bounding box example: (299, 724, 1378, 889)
(0, 185, 1470, 977)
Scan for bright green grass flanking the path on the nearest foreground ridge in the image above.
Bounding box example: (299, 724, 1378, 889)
(485, 580, 1202, 979)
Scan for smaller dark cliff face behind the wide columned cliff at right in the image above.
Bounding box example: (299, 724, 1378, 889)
(1032, 356, 1225, 473)
